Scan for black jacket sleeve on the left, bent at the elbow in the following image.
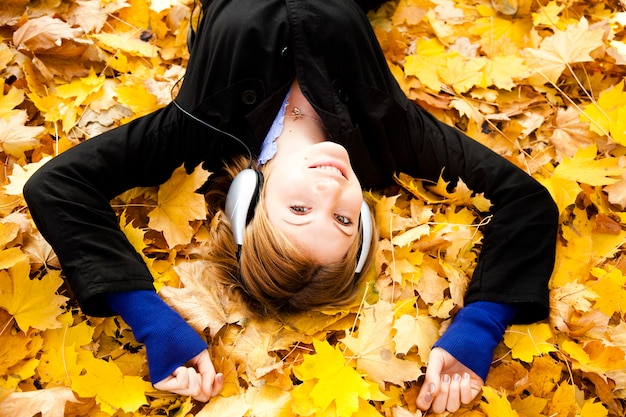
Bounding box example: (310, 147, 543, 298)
(24, 106, 227, 316)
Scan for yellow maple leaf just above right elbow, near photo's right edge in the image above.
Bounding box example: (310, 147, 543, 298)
(554, 144, 626, 186)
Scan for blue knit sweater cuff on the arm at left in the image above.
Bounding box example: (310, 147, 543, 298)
(105, 290, 207, 383)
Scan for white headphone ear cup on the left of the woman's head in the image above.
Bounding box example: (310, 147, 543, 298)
(224, 168, 263, 245)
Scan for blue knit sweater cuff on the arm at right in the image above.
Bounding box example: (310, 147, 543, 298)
(434, 301, 516, 381)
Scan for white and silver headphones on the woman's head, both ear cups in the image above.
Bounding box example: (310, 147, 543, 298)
(225, 168, 373, 274)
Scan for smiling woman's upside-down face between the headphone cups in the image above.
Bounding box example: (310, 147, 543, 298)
(264, 140, 363, 264)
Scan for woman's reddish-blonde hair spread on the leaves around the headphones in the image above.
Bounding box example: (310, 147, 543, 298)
(207, 158, 377, 317)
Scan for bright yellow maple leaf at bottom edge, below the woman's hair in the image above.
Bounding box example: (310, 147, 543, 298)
(292, 339, 386, 417)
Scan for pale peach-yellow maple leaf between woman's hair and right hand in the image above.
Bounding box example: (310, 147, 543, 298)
(340, 300, 422, 386)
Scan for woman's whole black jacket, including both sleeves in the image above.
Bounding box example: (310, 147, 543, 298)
(24, 0, 558, 322)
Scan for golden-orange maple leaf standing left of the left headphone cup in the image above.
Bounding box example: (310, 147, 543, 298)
(148, 162, 209, 248)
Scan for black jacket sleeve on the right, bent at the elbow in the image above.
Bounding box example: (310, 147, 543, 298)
(399, 106, 558, 323)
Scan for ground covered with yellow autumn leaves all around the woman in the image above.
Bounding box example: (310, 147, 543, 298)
(0, 0, 626, 417)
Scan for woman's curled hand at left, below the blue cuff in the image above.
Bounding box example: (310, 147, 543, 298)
(154, 350, 224, 402)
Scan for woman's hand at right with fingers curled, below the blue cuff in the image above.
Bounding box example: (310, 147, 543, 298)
(417, 347, 485, 413)
